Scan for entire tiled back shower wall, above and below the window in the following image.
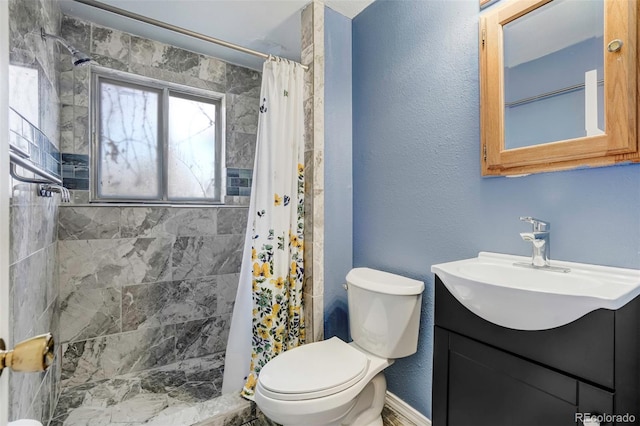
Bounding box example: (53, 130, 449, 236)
(58, 16, 261, 386)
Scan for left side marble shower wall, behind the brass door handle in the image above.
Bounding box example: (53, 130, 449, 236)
(8, 0, 62, 424)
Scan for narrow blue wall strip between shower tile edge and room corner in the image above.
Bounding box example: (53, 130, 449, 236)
(324, 8, 353, 340)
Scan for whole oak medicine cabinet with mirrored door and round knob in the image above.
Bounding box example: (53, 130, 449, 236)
(479, 0, 640, 176)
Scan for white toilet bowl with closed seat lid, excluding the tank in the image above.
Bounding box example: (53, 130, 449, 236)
(255, 337, 393, 426)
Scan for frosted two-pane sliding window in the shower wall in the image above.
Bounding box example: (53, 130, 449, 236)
(92, 69, 224, 203)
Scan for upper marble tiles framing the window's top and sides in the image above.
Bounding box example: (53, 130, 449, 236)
(60, 16, 262, 205)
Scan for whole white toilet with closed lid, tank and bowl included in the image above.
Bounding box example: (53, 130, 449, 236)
(255, 268, 424, 426)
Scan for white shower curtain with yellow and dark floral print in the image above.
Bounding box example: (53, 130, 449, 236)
(222, 58, 305, 399)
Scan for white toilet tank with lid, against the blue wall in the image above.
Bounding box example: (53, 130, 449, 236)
(347, 268, 424, 359)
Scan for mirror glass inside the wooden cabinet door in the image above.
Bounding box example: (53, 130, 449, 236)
(503, 0, 605, 149)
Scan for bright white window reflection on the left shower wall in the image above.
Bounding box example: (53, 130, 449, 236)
(9, 65, 40, 126)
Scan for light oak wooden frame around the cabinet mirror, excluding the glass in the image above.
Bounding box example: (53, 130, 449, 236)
(479, 0, 640, 176)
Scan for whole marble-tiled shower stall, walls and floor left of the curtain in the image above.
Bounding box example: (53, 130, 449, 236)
(9, 0, 320, 426)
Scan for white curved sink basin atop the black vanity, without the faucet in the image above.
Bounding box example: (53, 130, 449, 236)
(431, 252, 640, 330)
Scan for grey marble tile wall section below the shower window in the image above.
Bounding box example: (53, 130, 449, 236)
(58, 205, 247, 388)
